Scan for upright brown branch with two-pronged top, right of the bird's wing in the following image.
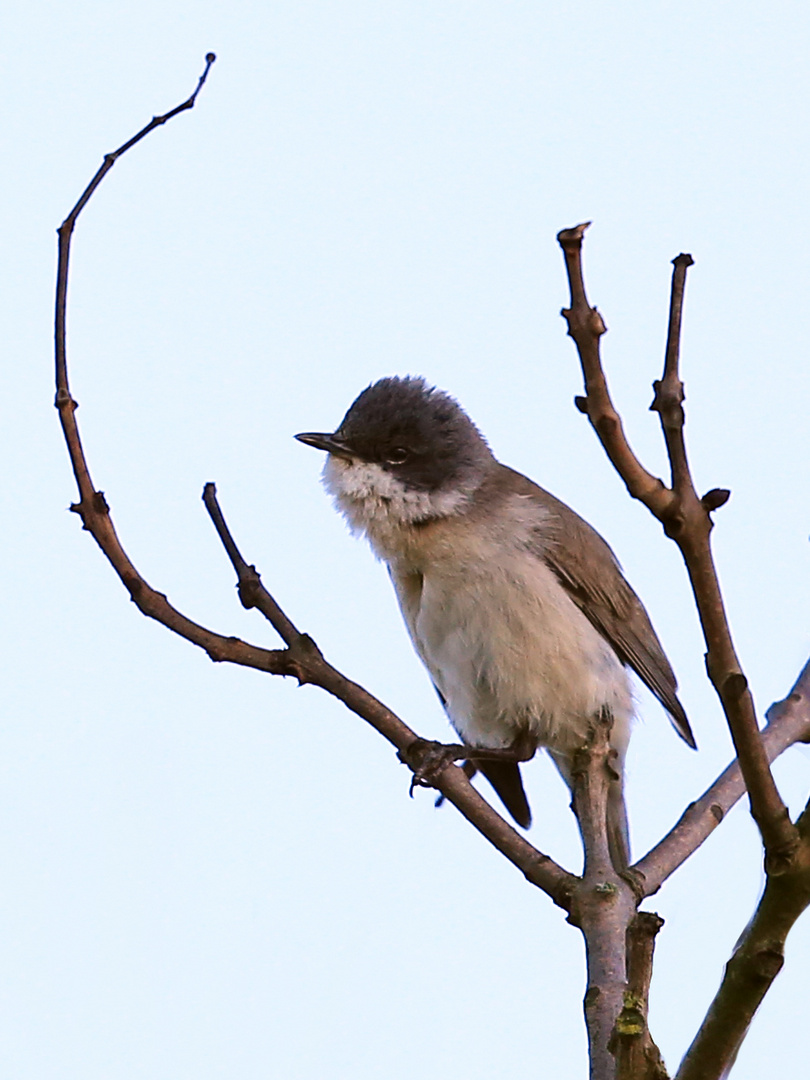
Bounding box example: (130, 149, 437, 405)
(557, 225, 798, 873)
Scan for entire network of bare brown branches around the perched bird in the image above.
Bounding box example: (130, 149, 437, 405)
(49, 61, 810, 1080)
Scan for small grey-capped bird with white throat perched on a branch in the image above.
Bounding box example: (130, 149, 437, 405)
(295, 376, 696, 868)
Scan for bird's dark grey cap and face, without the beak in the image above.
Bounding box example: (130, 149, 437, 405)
(335, 376, 492, 491)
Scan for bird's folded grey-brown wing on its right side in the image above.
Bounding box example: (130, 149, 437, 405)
(501, 467, 697, 750)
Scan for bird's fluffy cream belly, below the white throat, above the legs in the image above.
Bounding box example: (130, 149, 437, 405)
(408, 557, 632, 754)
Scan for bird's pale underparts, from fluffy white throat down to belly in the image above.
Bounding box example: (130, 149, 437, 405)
(324, 458, 633, 756)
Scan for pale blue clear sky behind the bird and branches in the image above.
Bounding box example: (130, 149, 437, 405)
(0, 0, 810, 1080)
